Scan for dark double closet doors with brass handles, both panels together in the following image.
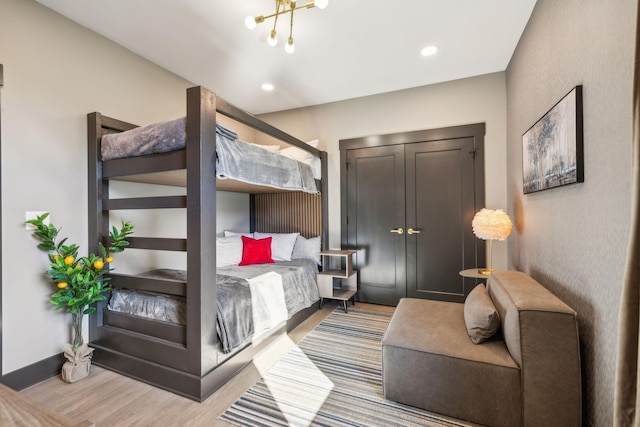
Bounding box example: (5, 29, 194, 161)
(340, 124, 485, 305)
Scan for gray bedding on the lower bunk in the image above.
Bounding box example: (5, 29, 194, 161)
(107, 259, 319, 353)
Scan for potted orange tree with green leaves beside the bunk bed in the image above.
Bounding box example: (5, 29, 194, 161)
(26, 212, 133, 382)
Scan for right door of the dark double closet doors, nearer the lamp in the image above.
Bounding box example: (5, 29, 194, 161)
(405, 138, 475, 302)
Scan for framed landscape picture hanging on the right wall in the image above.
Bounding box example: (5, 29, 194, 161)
(522, 85, 584, 194)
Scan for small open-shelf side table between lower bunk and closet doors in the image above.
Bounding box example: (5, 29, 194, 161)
(317, 249, 358, 313)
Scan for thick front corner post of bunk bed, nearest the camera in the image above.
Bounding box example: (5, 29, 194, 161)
(186, 87, 218, 376)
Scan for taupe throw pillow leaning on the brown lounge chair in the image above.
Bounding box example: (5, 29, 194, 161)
(464, 284, 500, 344)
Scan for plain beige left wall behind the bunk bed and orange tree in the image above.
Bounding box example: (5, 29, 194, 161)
(0, 0, 248, 373)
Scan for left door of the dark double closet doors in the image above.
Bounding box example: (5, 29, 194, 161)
(347, 146, 406, 305)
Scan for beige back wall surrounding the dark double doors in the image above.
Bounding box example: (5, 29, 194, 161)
(262, 72, 507, 268)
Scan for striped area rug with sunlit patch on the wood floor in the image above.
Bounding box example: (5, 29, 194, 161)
(220, 307, 467, 427)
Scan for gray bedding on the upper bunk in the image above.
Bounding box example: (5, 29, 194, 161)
(101, 117, 318, 194)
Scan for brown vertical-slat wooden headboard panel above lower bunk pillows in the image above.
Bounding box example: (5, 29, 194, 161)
(254, 192, 322, 238)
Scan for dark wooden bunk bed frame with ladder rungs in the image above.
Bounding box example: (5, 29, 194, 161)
(87, 87, 328, 401)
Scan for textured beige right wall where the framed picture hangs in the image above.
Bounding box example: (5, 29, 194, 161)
(507, 0, 637, 426)
